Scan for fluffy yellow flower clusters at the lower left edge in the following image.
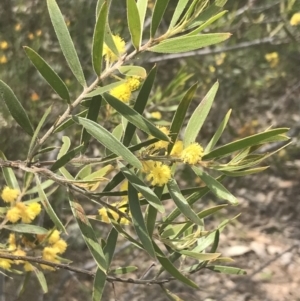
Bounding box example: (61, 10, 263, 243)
(0, 186, 67, 271)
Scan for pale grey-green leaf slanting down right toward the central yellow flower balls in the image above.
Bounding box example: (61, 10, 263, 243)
(73, 117, 142, 169)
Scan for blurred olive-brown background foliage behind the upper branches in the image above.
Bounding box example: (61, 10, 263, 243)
(0, 0, 300, 300)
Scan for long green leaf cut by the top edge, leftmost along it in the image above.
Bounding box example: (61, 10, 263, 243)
(47, 0, 86, 87)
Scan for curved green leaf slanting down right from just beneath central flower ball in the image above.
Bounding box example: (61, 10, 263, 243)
(167, 179, 203, 226)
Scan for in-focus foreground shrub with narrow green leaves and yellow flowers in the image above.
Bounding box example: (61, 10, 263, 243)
(0, 0, 288, 300)
